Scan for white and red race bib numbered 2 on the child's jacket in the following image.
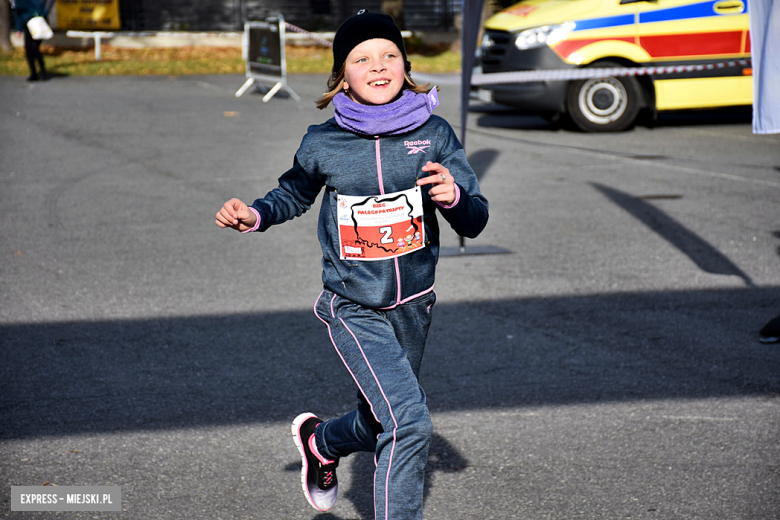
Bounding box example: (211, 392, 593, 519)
(338, 187, 425, 260)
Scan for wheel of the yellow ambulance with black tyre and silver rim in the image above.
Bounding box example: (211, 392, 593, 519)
(566, 61, 642, 132)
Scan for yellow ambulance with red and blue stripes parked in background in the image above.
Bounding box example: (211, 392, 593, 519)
(480, 0, 753, 132)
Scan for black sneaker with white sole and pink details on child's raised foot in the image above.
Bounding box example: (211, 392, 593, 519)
(292, 413, 339, 511)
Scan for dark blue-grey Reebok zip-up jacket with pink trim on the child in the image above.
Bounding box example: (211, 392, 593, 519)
(247, 115, 488, 309)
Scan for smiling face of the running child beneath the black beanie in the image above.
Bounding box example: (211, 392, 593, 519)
(344, 38, 404, 105)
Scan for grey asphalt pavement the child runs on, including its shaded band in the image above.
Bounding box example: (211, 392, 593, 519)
(0, 75, 780, 520)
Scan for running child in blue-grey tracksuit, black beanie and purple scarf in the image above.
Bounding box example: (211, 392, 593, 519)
(216, 11, 488, 520)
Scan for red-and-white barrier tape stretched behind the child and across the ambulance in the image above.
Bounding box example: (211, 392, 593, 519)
(285, 22, 750, 85)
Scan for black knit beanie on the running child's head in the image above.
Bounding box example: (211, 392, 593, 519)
(333, 10, 406, 74)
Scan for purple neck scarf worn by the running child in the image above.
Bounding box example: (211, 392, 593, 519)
(333, 87, 439, 135)
